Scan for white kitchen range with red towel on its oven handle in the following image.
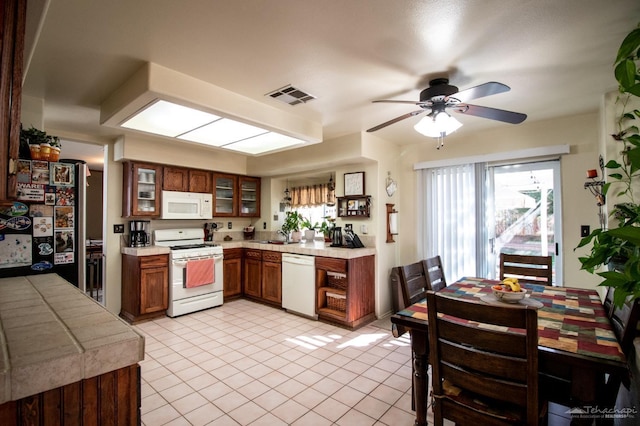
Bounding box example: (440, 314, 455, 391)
(154, 228, 224, 317)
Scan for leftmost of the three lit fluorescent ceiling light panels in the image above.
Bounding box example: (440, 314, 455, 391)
(122, 100, 220, 137)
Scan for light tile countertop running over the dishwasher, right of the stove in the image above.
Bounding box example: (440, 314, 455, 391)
(215, 240, 376, 259)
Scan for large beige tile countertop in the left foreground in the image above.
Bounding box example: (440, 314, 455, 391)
(0, 274, 144, 403)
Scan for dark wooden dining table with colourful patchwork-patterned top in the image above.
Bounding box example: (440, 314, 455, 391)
(391, 277, 629, 426)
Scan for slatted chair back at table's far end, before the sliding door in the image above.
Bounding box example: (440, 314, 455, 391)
(500, 253, 553, 285)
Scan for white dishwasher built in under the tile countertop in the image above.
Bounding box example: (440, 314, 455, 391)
(282, 253, 318, 319)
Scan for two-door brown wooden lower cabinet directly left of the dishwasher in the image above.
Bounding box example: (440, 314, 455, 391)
(243, 249, 282, 306)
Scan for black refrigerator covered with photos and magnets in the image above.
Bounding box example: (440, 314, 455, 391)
(0, 160, 87, 289)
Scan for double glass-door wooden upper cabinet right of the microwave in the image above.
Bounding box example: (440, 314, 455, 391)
(213, 172, 260, 217)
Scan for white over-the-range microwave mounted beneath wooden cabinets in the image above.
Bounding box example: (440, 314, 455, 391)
(162, 191, 213, 219)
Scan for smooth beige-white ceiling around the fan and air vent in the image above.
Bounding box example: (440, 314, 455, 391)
(24, 0, 640, 166)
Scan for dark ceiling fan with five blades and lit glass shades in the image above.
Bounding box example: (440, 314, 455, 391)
(367, 78, 527, 138)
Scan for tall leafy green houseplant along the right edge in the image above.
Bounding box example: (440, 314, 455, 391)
(578, 23, 640, 306)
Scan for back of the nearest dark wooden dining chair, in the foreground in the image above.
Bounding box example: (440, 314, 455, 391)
(427, 291, 539, 425)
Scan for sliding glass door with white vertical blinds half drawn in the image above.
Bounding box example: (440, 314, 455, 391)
(418, 160, 562, 285)
